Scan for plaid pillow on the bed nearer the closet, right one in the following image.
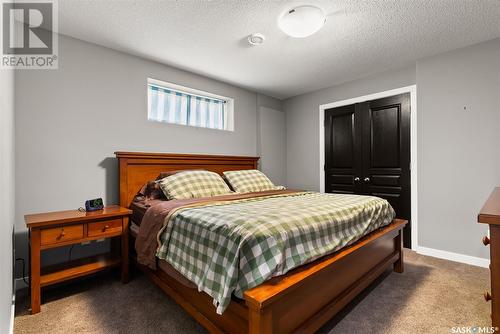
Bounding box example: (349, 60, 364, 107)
(224, 169, 285, 193)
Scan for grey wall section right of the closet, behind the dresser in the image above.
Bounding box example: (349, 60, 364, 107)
(417, 39, 500, 258)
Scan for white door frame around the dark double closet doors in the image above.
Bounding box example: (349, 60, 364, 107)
(319, 85, 418, 250)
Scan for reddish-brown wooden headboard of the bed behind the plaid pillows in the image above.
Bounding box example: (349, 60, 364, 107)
(115, 152, 259, 208)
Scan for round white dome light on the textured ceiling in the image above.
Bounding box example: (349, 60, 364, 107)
(278, 5, 326, 38)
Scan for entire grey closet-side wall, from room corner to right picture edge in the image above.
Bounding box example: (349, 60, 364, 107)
(284, 40, 500, 258)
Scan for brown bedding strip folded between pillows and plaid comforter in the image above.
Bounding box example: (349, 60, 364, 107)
(135, 190, 297, 269)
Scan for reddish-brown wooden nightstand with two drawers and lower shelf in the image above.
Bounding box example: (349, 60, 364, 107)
(24, 206, 132, 314)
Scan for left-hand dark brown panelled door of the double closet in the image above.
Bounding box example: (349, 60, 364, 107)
(325, 105, 363, 194)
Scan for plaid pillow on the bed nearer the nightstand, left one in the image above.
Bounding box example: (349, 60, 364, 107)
(157, 170, 232, 200)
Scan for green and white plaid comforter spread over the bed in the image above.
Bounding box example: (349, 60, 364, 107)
(156, 192, 395, 314)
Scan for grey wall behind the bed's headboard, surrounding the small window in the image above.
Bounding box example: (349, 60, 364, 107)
(15, 36, 280, 274)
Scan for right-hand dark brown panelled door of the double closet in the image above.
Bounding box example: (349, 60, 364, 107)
(362, 94, 411, 247)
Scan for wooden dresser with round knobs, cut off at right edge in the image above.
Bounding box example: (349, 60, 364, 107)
(477, 187, 500, 328)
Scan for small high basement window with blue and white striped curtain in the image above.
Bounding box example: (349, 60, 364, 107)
(148, 79, 234, 131)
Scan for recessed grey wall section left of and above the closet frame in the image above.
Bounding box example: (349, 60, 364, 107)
(283, 66, 415, 190)
